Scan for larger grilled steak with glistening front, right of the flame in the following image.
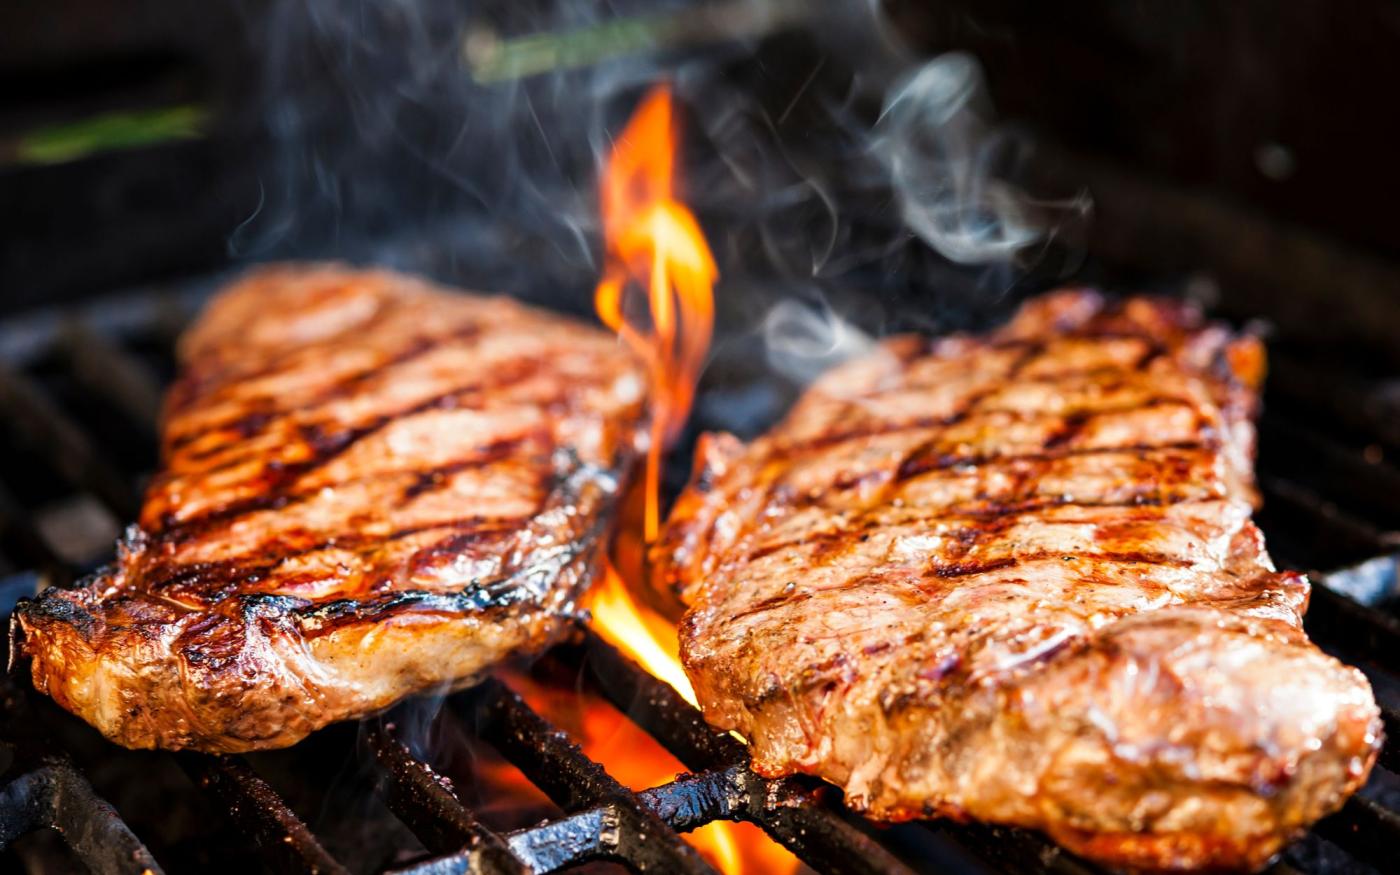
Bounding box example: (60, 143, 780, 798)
(652, 293, 1380, 868)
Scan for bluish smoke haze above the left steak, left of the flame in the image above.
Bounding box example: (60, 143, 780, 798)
(230, 0, 624, 270)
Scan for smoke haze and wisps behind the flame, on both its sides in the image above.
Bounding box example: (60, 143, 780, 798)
(230, 0, 1084, 294)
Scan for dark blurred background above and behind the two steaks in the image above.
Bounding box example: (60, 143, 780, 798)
(0, 0, 1400, 354)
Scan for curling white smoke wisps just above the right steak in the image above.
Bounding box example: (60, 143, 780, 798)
(744, 52, 1092, 385)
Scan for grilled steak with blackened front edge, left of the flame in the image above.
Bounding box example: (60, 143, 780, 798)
(18, 266, 644, 752)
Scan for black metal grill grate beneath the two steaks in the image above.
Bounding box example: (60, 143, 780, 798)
(0, 274, 1400, 875)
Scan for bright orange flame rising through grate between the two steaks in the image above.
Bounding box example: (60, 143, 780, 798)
(585, 85, 798, 875)
